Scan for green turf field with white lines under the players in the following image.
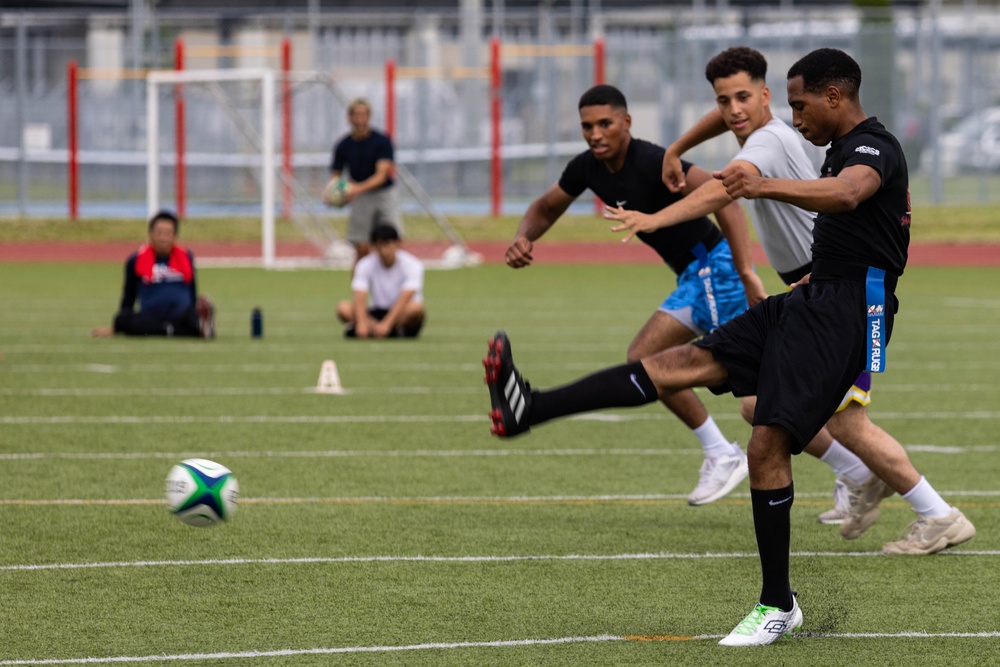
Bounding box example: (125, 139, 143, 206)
(0, 264, 1000, 667)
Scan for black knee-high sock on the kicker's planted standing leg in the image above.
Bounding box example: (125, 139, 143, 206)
(750, 484, 795, 611)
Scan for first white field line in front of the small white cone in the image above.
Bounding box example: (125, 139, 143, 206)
(0, 410, 1000, 426)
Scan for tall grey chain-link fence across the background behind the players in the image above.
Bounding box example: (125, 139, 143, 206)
(0, 2, 1000, 216)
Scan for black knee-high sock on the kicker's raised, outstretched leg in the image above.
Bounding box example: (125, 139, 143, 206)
(528, 361, 658, 426)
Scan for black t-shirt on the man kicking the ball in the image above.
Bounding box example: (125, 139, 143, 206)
(812, 116, 910, 276)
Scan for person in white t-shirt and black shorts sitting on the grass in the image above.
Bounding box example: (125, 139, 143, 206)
(337, 225, 424, 338)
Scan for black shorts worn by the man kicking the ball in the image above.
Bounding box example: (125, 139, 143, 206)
(694, 280, 895, 454)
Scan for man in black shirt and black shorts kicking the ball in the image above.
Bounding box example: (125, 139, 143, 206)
(485, 49, 975, 646)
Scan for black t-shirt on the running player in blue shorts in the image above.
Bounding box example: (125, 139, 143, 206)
(559, 137, 722, 275)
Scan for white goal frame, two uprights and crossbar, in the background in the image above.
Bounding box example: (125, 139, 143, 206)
(146, 68, 275, 268)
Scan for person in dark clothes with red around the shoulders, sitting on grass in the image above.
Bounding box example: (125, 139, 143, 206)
(92, 211, 215, 340)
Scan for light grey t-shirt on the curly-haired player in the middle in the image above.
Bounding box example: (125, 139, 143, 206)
(733, 118, 818, 273)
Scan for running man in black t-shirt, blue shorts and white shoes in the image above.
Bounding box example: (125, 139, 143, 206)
(497, 85, 766, 505)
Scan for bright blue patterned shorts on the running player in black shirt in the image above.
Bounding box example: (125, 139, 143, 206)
(660, 239, 747, 336)
